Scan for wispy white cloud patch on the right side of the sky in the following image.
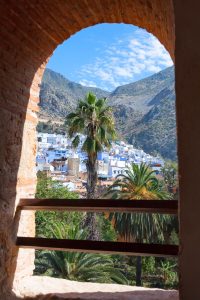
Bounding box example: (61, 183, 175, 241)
(78, 29, 173, 90)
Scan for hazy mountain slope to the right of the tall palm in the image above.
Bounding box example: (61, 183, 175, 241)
(109, 67, 177, 160)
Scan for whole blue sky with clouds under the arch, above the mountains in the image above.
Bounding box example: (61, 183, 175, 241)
(47, 24, 173, 91)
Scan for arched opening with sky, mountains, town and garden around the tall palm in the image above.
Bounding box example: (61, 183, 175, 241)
(32, 24, 178, 288)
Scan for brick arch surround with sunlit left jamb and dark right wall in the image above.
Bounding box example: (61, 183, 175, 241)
(6, 0, 200, 300)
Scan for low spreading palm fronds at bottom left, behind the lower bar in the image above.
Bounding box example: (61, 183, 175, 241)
(35, 223, 128, 284)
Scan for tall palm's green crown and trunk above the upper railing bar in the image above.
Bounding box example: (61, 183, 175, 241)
(67, 93, 116, 199)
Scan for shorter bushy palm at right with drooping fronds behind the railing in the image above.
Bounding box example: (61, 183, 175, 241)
(106, 163, 170, 286)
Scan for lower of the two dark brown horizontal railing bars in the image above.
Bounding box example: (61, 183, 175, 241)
(16, 237, 179, 257)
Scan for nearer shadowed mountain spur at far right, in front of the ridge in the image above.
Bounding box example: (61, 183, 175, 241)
(127, 85, 177, 160)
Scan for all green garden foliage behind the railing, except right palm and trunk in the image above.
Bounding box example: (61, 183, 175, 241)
(35, 172, 178, 288)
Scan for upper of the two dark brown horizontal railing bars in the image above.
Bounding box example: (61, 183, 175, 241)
(18, 199, 178, 214)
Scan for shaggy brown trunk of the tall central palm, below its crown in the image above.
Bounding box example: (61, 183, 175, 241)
(84, 156, 100, 241)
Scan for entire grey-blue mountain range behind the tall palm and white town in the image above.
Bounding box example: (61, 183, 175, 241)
(39, 67, 176, 160)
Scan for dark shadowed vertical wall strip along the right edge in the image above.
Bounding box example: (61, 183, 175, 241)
(174, 0, 200, 300)
